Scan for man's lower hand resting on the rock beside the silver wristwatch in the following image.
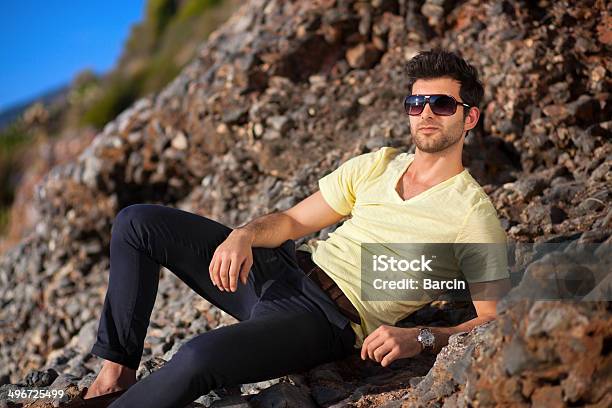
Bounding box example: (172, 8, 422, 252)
(361, 325, 422, 367)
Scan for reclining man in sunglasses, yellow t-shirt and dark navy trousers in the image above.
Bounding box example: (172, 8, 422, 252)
(85, 50, 507, 407)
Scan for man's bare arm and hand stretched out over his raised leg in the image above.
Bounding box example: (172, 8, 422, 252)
(208, 191, 344, 292)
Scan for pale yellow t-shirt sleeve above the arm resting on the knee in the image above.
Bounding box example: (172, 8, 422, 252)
(319, 148, 384, 215)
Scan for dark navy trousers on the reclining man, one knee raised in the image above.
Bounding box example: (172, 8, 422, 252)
(91, 204, 357, 408)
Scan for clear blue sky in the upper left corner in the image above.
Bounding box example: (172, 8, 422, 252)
(0, 0, 145, 111)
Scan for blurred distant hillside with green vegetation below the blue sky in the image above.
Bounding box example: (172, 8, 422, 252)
(0, 0, 240, 254)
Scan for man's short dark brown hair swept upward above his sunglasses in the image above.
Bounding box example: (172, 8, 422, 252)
(406, 48, 484, 136)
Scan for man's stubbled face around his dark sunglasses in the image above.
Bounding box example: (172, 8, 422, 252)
(409, 77, 478, 153)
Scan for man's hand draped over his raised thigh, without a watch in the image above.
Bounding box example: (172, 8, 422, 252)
(208, 230, 253, 292)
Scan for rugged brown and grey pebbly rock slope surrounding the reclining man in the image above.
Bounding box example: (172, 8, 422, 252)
(0, 0, 612, 407)
